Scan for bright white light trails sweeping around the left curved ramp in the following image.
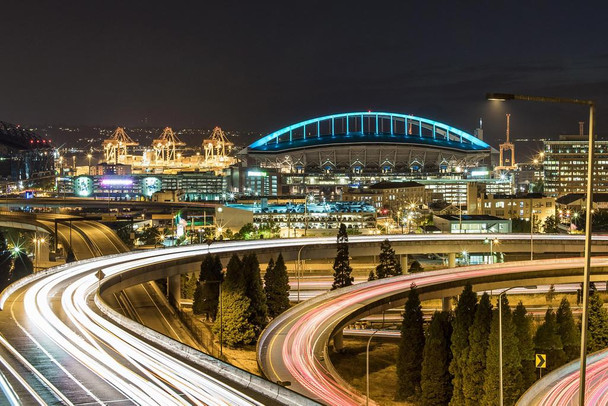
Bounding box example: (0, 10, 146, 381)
(20, 244, 268, 405)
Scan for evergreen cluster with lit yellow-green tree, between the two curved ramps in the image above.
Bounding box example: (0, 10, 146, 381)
(192, 253, 289, 347)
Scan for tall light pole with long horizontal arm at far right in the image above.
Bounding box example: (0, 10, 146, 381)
(486, 93, 595, 405)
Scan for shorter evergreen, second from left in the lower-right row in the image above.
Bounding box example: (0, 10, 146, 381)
(420, 312, 452, 406)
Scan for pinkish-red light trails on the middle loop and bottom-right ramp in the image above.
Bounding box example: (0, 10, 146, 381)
(261, 258, 608, 406)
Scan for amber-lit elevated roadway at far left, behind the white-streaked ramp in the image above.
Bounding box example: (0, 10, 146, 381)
(0, 212, 130, 260)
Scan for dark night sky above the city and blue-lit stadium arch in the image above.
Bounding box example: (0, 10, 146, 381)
(0, 0, 608, 155)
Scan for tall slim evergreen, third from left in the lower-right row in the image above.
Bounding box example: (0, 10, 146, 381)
(450, 283, 477, 406)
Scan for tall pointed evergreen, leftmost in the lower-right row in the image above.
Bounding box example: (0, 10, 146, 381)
(397, 284, 424, 399)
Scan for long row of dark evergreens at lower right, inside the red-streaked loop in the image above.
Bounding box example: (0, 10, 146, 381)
(396, 284, 608, 406)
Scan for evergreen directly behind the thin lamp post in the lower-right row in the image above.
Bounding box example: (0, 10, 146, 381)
(482, 295, 523, 406)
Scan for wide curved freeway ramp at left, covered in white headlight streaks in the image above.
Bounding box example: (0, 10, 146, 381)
(0, 243, 316, 406)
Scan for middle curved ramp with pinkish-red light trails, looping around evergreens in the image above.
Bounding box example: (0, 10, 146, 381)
(257, 258, 608, 405)
